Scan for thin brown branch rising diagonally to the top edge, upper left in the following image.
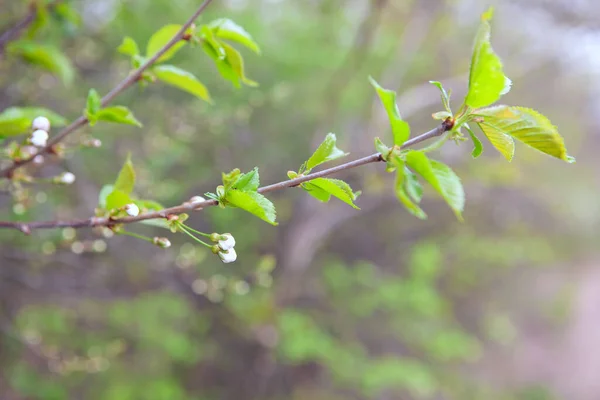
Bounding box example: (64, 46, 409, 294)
(0, 0, 212, 179)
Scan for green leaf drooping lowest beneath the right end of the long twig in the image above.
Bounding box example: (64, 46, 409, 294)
(406, 151, 465, 221)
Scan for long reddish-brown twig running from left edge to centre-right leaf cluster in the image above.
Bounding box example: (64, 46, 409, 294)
(0, 122, 452, 234)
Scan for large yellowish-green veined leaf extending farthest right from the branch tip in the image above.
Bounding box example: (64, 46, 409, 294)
(472, 106, 575, 162)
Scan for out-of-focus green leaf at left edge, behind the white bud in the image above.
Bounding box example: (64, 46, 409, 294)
(0, 107, 68, 137)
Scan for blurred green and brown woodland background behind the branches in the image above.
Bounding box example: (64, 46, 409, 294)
(0, 0, 600, 400)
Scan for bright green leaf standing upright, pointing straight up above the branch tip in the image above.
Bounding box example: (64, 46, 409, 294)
(465, 8, 511, 108)
